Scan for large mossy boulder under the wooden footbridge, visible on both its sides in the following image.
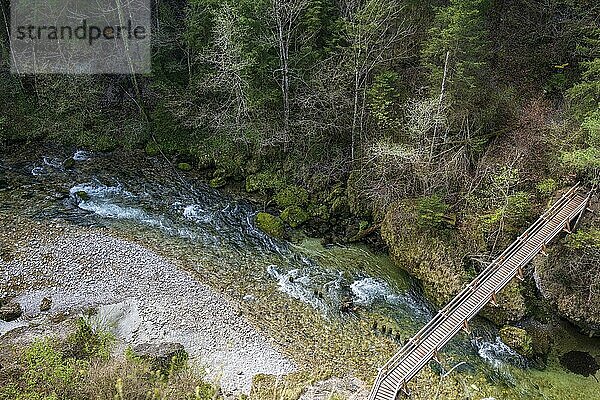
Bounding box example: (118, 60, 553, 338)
(381, 196, 526, 325)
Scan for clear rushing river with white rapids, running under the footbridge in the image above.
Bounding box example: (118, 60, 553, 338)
(0, 147, 597, 399)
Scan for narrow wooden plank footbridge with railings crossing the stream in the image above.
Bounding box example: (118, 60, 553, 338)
(369, 184, 591, 400)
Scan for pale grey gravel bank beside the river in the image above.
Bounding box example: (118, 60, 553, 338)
(0, 222, 294, 393)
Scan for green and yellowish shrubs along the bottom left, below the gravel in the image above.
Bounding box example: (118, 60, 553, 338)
(0, 319, 215, 400)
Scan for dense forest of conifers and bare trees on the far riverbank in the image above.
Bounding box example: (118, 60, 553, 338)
(0, 0, 600, 398)
